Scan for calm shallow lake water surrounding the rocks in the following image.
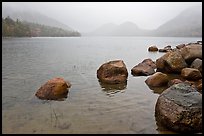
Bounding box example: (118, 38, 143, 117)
(2, 37, 202, 134)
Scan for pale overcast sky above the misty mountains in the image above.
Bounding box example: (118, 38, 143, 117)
(2, 2, 202, 32)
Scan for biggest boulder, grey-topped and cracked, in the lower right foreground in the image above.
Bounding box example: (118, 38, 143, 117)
(155, 83, 202, 133)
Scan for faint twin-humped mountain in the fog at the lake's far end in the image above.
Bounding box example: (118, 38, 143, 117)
(87, 22, 149, 36)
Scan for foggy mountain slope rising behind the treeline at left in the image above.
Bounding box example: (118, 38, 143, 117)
(2, 5, 74, 31)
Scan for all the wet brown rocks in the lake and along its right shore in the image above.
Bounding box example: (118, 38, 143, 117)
(35, 41, 202, 133)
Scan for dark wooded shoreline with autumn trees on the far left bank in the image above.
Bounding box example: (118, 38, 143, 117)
(2, 17, 81, 37)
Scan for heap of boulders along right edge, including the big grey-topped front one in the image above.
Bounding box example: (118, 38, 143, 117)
(145, 42, 202, 132)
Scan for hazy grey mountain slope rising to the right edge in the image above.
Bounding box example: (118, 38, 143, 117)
(154, 6, 202, 36)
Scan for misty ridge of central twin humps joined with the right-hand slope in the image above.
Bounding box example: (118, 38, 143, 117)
(86, 6, 202, 37)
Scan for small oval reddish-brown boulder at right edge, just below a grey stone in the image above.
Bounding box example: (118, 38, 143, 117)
(181, 68, 202, 80)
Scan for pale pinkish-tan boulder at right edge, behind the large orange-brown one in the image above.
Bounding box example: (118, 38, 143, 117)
(180, 44, 202, 65)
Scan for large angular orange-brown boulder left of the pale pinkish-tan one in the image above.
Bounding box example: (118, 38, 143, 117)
(156, 50, 187, 73)
